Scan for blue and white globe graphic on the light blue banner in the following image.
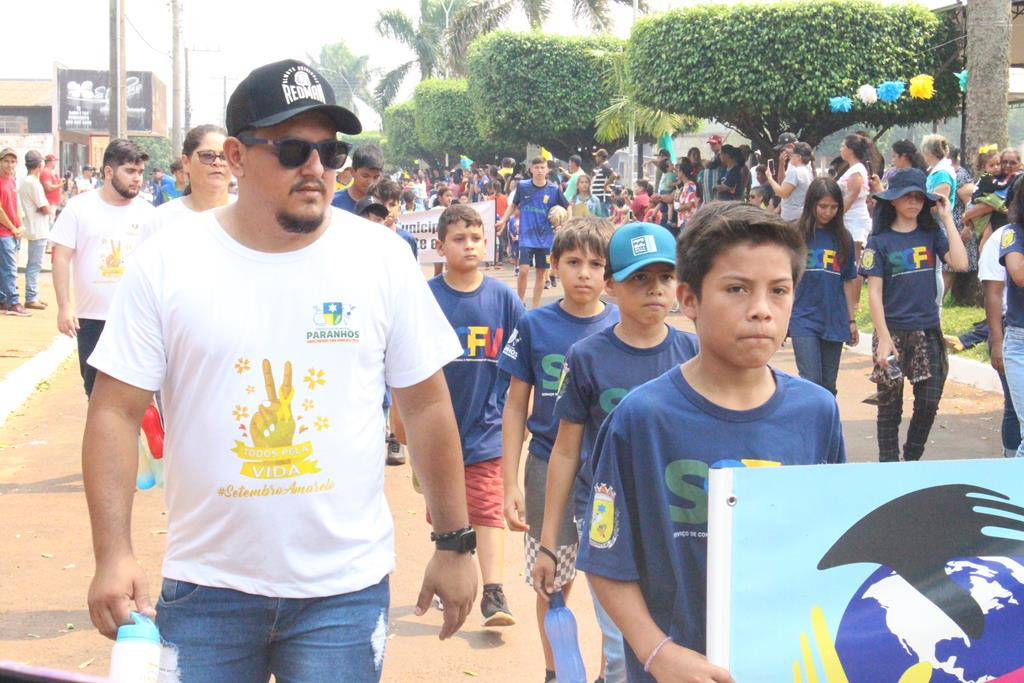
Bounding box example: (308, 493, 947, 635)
(836, 557, 1024, 683)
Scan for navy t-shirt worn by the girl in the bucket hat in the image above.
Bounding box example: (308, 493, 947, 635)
(860, 227, 949, 330)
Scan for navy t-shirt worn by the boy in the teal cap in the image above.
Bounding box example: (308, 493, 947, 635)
(555, 326, 697, 519)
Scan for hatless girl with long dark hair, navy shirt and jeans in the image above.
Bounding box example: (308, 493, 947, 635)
(790, 177, 859, 394)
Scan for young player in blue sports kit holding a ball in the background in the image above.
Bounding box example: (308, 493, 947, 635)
(495, 157, 569, 308)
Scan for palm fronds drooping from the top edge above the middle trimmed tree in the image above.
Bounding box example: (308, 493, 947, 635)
(447, 0, 647, 67)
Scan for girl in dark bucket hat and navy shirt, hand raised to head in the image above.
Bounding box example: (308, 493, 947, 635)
(860, 168, 967, 462)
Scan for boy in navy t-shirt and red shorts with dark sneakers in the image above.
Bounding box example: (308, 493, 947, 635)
(428, 204, 523, 627)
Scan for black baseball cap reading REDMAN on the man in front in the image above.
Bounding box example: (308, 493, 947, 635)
(224, 59, 362, 136)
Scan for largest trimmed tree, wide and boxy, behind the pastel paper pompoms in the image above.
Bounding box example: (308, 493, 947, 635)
(627, 0, 959, 150)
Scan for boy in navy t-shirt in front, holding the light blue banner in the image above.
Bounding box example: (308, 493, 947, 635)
(579, 203, 846, 682)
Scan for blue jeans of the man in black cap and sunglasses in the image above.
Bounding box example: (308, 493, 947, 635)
(157, 577, 390, 683)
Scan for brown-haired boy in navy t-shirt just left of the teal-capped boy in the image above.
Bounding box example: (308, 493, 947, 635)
(498, 216, 618, 677)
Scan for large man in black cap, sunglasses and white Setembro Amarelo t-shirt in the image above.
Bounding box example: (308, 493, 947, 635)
(83, 59, 476, 683)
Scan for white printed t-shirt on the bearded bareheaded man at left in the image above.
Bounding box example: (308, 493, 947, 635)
(50, 191, 154, 321)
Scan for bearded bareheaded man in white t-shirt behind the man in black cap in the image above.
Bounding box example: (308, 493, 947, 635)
(50, 138, 153, 396)
